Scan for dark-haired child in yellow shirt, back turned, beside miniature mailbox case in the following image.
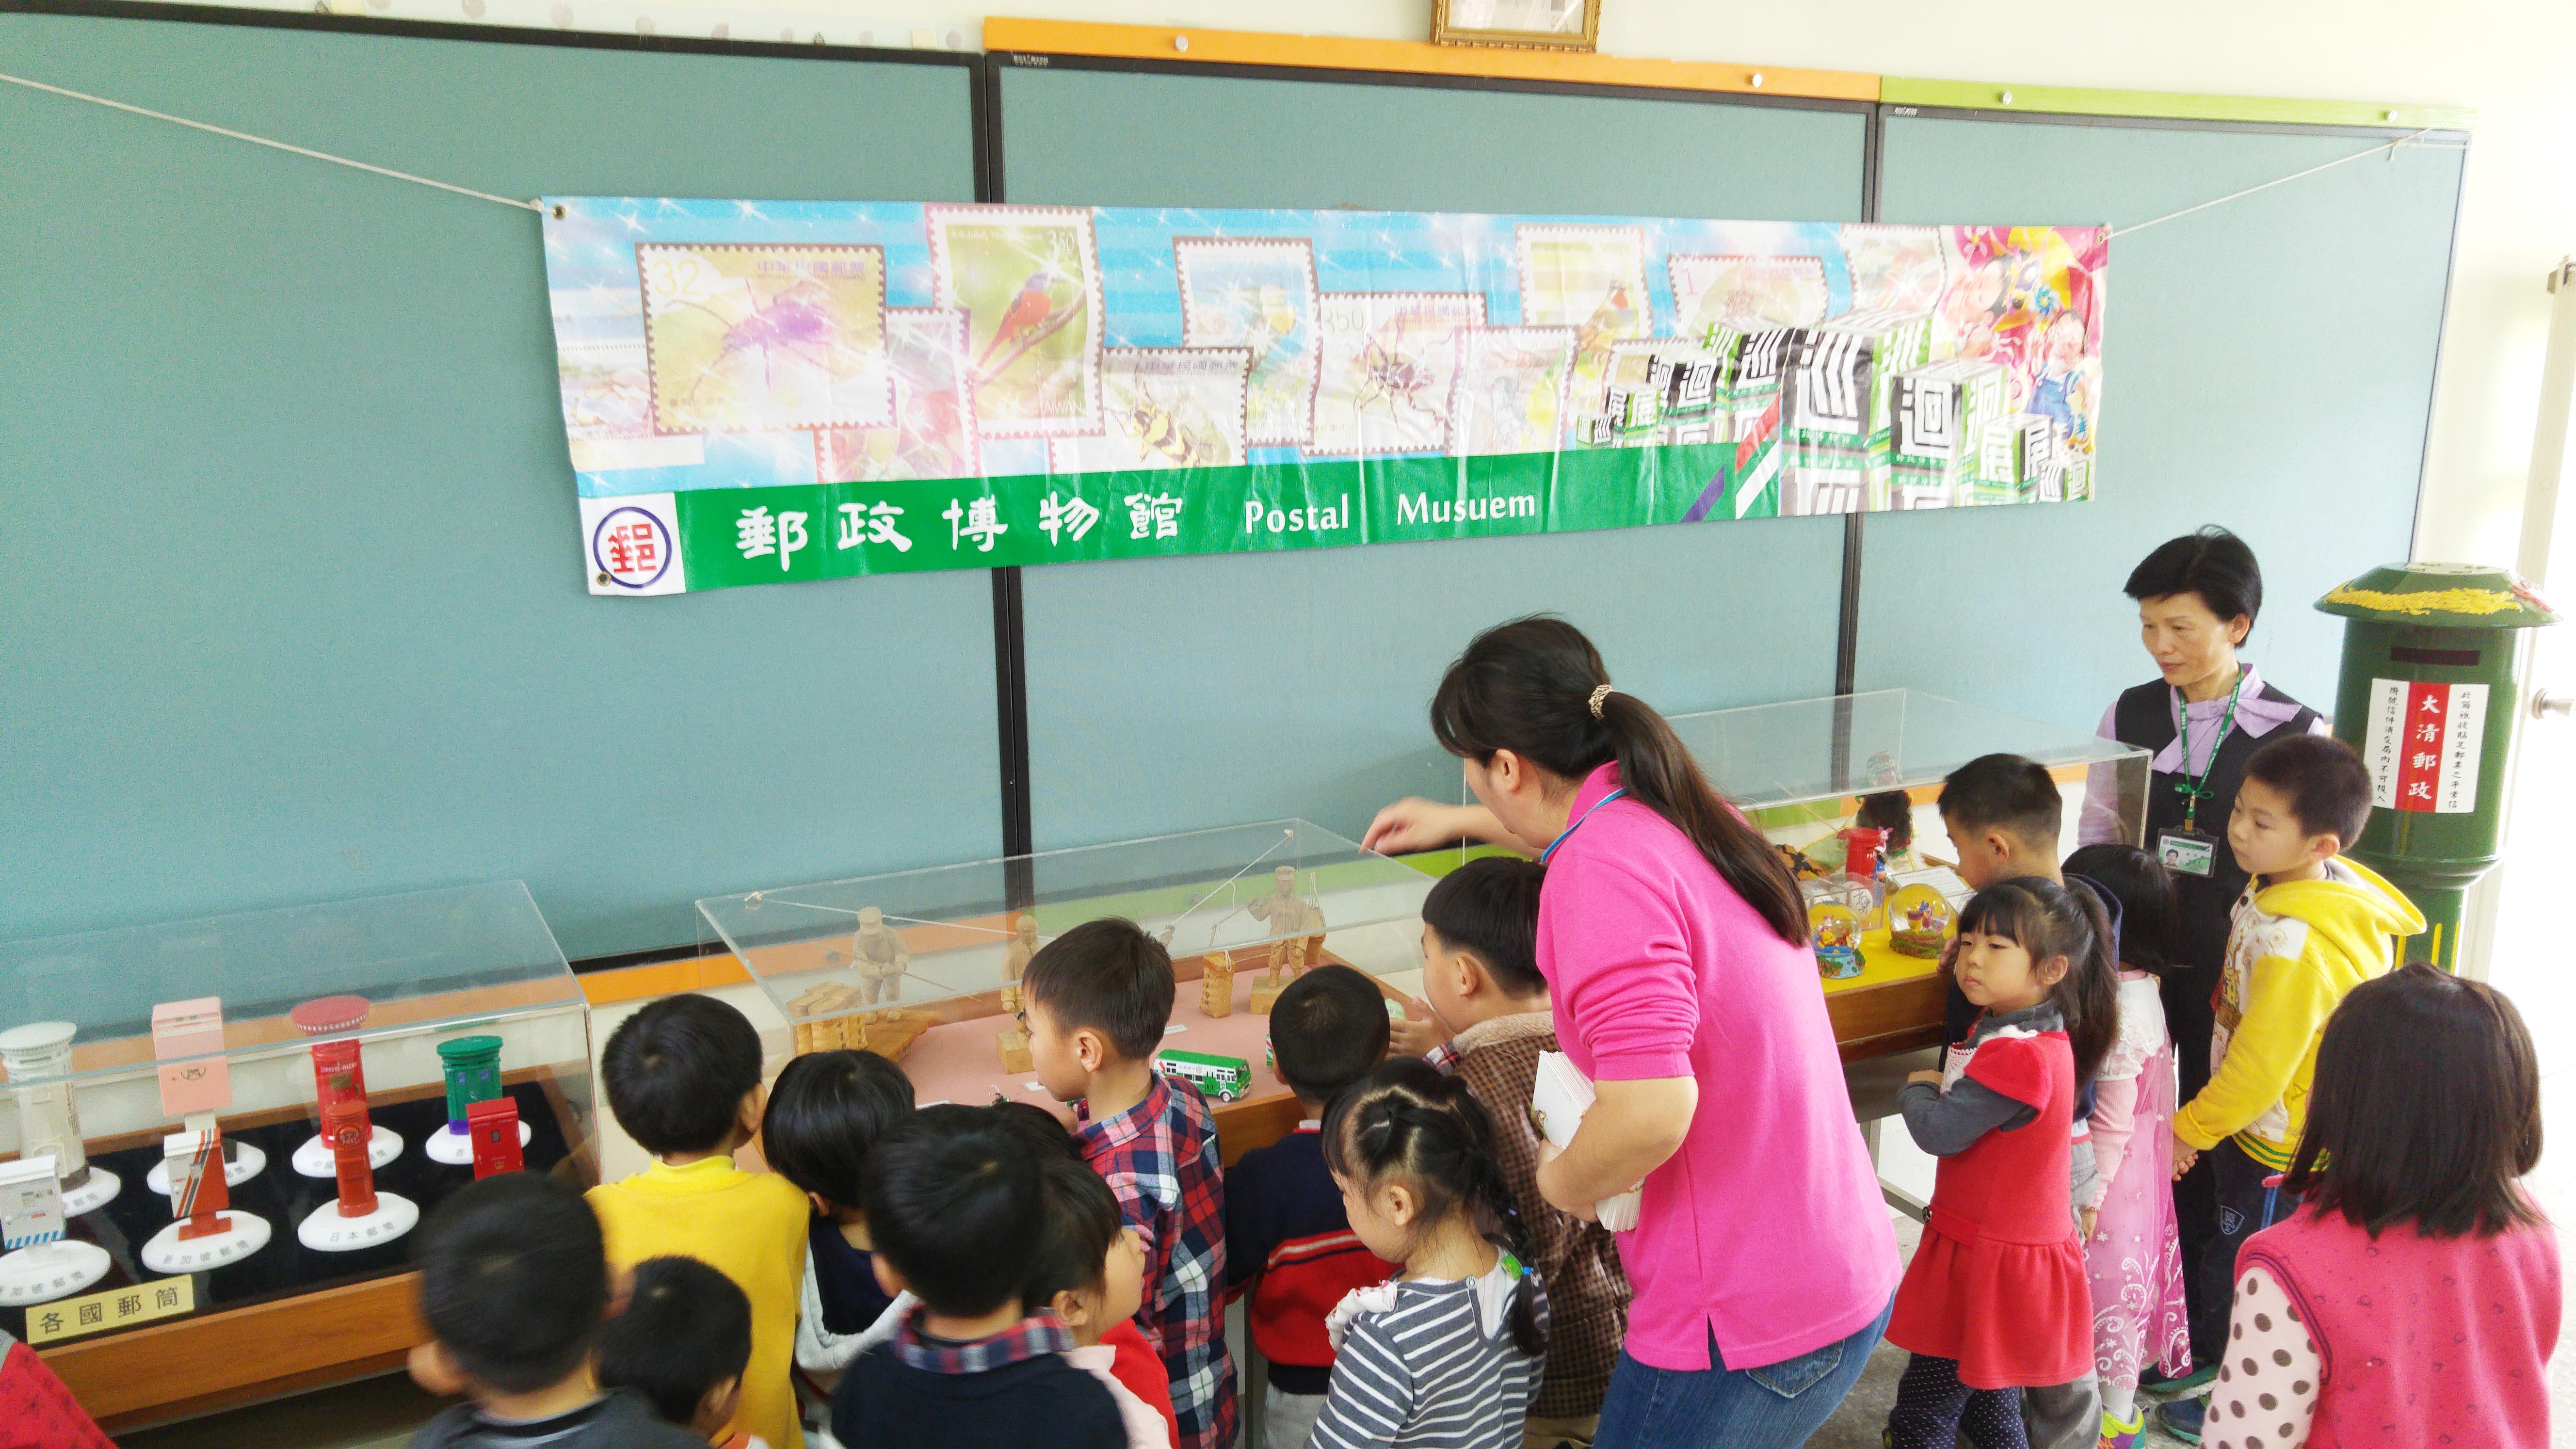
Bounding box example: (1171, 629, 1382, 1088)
(590, 995, 806, 1449)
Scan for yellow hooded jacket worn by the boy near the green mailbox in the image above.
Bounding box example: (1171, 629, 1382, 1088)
(2174, 856, 2424, 1171)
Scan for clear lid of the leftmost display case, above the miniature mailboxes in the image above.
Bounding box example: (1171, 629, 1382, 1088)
(0, 879, 585, 1075)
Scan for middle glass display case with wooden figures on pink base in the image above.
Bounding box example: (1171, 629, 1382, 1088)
(698, 820, 1432, 1106)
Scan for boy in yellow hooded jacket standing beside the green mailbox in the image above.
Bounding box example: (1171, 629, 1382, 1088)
(2166, 735, 2424, 1441)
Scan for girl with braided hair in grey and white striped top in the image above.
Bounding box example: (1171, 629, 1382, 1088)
(1311, 1057, 1548, 1449)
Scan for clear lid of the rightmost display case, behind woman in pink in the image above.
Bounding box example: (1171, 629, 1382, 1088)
(1672, 689, 2148, 809)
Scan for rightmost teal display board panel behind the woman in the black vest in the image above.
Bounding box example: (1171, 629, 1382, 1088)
(1857, 116, 2465, 730)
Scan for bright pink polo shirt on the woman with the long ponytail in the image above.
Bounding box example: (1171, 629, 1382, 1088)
(1538, 766, 1899, 1369)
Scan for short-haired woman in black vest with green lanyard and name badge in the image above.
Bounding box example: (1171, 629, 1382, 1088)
(2076, 526, 2326, 1392)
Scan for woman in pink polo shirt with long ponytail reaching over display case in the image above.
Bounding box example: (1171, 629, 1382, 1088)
(1368, 616, 1899, 1449)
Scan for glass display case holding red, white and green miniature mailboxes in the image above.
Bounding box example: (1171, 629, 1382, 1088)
(0, 882, 595, 1340)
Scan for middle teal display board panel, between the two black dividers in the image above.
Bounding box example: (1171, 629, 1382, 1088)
(994, 64, 1868, 848)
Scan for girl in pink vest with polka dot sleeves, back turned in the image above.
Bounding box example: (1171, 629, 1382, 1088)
(2203, 964, 2558, 1449)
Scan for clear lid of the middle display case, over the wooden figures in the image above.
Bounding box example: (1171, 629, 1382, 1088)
(698, 820, 1432, 1021)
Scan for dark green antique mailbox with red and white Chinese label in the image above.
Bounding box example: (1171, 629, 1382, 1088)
(2316, 564, 2558, 969)
